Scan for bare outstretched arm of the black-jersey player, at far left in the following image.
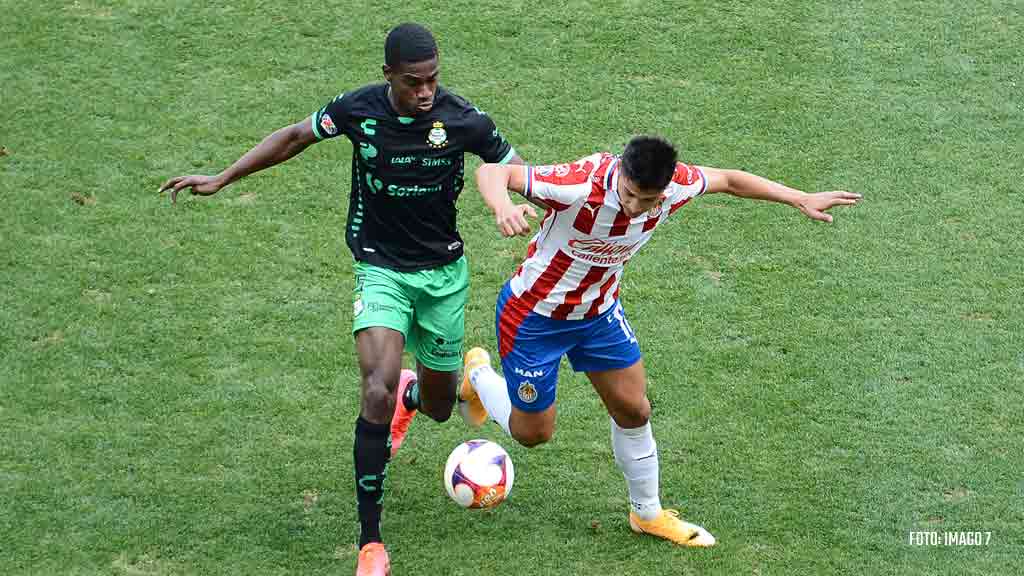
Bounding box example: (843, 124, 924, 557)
(160, 119, 316, 203)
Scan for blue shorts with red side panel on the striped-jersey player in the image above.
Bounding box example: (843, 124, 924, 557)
(495, 283, 640, 412)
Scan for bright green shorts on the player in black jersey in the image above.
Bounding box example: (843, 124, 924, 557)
(352, 256, 469, 372)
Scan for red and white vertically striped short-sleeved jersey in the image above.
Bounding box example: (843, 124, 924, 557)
(510, 153, 708, 320)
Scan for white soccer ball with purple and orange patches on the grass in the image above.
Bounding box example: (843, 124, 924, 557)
(444, 440, 515, 508)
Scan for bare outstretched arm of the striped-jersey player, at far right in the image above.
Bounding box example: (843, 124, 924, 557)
(700, 166, 861, 222)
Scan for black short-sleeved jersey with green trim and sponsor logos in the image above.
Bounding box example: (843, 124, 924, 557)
(310, 84, 515, 272)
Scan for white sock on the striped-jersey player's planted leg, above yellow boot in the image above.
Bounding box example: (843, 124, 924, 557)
(611, 420, 662, 520)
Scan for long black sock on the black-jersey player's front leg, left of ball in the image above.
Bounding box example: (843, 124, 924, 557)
(352, 416, 391, 548)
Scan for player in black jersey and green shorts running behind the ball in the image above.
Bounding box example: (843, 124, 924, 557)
(160, 24, 532, 575)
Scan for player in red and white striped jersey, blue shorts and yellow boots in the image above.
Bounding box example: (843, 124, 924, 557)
(460, 136, 860, 546)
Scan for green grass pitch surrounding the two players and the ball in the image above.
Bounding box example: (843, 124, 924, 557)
(0, 0, 1024, 575)
